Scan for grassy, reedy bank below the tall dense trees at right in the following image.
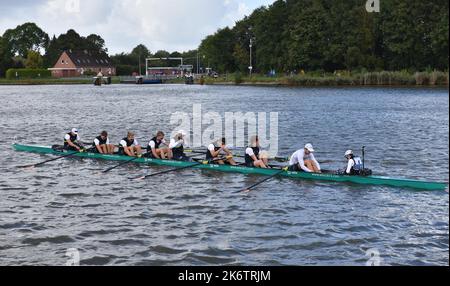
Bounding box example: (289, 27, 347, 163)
(204, 71, 449, 86)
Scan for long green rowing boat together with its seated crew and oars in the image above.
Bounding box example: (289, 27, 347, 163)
(13, 129, 447, 191)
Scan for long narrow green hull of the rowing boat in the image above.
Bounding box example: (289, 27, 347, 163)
(13, 144, 447, 190)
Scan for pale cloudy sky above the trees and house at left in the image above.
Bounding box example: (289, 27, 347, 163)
(0, 0, 274, 54)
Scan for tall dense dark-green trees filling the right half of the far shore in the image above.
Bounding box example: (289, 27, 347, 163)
(200, 0, 449, 73)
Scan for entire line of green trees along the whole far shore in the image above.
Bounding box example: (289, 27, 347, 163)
(0, 0, 449, 76)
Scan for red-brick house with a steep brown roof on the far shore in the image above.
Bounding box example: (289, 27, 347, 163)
(49, 50, 116, 77)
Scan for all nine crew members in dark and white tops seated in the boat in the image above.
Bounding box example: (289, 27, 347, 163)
(64, 128, 370, 175)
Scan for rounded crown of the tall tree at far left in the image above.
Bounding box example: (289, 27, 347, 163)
(3, 23, 49, 58)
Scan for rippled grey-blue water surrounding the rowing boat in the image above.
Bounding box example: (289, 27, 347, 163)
(0, 85, 449, 265)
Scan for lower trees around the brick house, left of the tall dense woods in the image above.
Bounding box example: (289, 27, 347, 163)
(0, 23, 197, 76)
